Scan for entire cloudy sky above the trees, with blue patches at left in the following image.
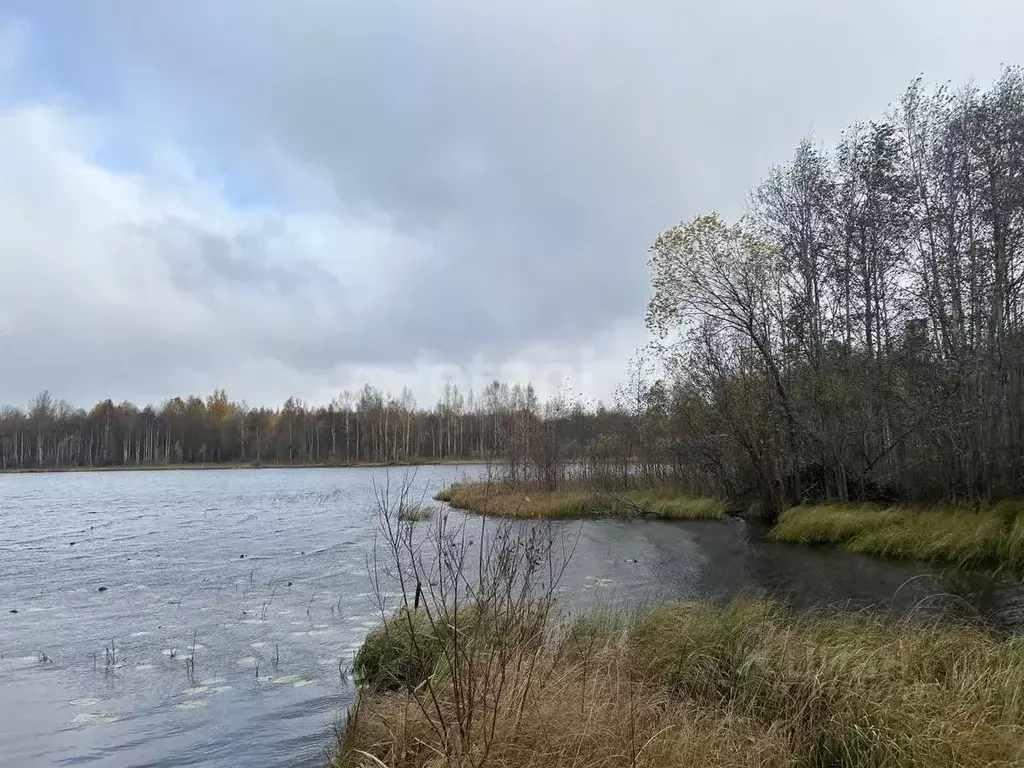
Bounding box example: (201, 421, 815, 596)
(0, 0, 1024, 406)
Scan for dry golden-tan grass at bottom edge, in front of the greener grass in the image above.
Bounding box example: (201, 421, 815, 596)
(333, 653, 791, 768)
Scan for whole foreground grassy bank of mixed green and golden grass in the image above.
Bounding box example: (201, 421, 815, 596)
(331, 601, 1024, 768)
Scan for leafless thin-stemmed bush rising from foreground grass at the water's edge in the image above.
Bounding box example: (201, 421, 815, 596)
(349, 476, 574, 765)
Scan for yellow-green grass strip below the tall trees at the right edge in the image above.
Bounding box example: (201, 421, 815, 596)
(771, 502, 1024, 569)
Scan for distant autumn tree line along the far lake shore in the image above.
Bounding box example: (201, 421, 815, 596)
(0, 381, 577, 470)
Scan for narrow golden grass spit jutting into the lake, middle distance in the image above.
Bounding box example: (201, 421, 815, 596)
(434, 483, 725, 520)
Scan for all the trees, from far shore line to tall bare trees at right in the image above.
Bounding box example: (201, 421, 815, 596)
(6, 68, 1024, 514)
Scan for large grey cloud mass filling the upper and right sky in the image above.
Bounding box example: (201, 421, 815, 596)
(2, 0, 1024, 405)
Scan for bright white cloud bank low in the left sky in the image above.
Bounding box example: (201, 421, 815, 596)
(0, 98, 638, 404)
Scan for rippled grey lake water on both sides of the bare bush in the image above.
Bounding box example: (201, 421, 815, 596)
(0, 467, 1024, 766)
